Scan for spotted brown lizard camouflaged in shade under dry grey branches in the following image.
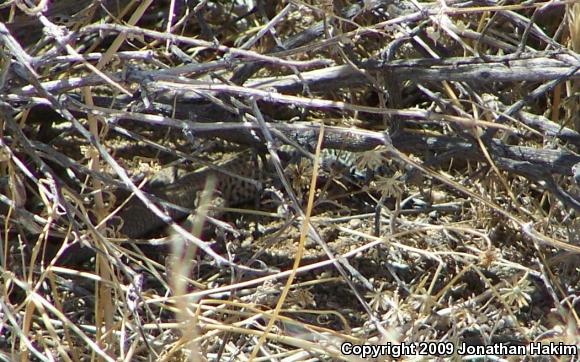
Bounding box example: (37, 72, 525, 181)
(113, 149, 373, 238)
